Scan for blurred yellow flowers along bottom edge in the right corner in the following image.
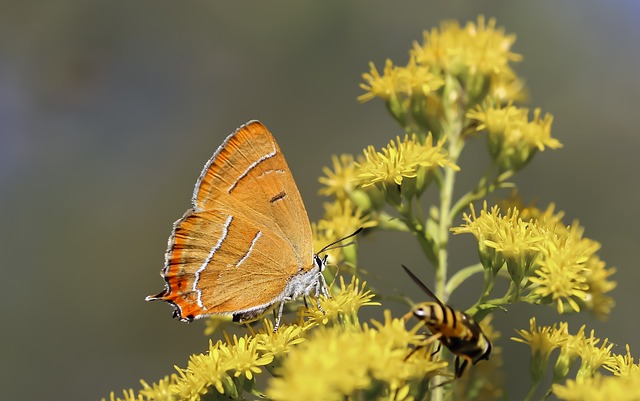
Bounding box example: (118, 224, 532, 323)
(551, 371, 640, 401)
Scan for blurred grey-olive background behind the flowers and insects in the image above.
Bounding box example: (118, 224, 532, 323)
(0, 0, 640, 400)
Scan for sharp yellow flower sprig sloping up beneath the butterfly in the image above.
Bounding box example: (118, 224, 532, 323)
(104, 277, 380, 401)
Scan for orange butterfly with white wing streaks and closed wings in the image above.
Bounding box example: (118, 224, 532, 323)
(146, 121, 330, 330)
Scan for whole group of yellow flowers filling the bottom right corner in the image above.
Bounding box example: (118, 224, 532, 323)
(512, 318, 640, 401)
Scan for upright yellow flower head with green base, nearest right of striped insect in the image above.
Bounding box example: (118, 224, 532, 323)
(511, 317, 568, 383)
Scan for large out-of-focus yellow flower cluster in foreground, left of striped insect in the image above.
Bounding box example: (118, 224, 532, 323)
(267, 311, 446, 401)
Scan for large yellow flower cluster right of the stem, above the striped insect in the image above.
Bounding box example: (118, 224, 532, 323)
(452, 203, 615, 318)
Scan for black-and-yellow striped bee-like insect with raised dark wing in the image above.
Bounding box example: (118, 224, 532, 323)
(402, 265, 491, 379)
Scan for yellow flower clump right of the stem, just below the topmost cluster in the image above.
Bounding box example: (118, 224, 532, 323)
(467, 104, 562, 171)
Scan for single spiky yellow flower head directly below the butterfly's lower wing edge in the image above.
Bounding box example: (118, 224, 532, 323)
(221, 335, 273, 380)
